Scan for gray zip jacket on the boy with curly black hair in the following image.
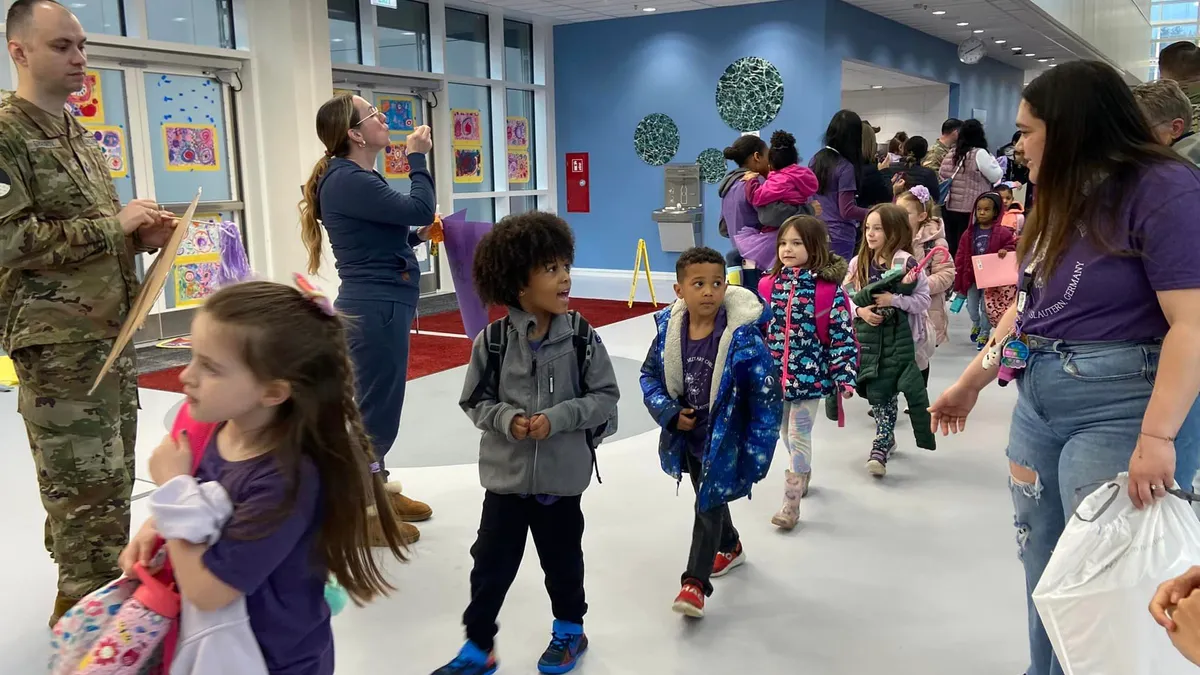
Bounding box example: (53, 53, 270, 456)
(458, 307, 620, 497)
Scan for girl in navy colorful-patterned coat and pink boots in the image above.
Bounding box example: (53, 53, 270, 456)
(758, 215, 858, 530)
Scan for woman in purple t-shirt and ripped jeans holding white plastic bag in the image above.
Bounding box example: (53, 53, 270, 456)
(931, 61, 1200, 675)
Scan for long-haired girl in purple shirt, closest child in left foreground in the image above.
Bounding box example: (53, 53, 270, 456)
(121, 281, 404, 675)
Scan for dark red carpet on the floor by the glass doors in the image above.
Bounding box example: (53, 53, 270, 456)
(138, 298, 655, 393)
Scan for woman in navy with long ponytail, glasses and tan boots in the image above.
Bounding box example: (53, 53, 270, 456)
(300, 95, 437, 545)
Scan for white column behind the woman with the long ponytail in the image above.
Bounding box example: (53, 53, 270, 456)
(238, 0, 337, 289)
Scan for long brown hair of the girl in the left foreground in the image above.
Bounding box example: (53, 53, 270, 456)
(202, 281, 406, 604)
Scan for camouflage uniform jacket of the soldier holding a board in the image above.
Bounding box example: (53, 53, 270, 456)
(0, 96, 138, 353)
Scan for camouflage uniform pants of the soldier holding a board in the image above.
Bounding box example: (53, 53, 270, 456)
(11, 341, 138, 598)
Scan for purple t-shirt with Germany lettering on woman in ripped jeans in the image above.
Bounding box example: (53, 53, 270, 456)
(1021, 162, 1200, 341)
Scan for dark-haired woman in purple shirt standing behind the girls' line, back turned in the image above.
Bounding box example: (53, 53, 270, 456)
(809, 110, 866, 261)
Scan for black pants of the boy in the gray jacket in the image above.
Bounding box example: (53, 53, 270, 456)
(462, 491, 588, 652)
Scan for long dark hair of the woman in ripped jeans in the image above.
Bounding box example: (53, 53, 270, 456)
(1018, 61, 1183, 282)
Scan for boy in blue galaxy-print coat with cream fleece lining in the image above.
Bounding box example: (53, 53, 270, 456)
(642, 249, 782, 619)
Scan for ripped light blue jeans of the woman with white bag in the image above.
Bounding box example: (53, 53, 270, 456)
(1008, 338, 1200, 675)
